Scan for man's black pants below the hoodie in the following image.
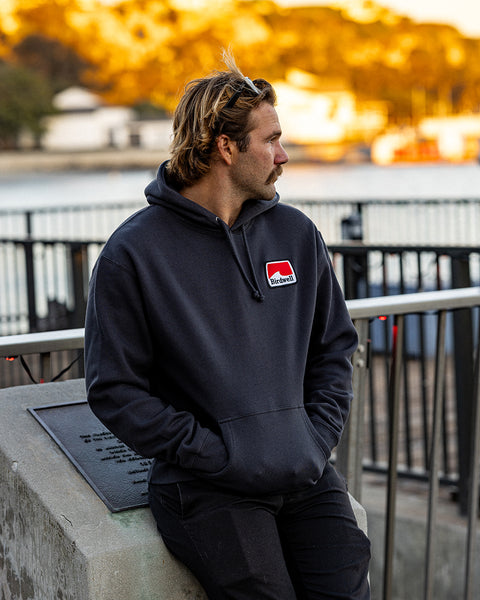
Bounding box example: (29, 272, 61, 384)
(150, 464, 370, 600)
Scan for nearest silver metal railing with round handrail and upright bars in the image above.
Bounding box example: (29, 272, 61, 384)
(0, 287, 480, 600)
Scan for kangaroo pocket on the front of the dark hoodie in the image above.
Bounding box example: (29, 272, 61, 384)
(204, 406, 326, 494)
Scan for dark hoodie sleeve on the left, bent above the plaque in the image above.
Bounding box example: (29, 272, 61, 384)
(85, 255, 227, 473)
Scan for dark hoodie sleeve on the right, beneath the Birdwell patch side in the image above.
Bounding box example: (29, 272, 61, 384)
(304, 234, 358, 459)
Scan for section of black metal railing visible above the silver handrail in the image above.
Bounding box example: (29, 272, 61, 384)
(0, 237, 480, 335)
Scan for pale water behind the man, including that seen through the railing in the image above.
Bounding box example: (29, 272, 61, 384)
(0, 163, 480, 246)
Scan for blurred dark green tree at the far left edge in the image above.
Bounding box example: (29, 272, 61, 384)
(0, 63, 54, 149)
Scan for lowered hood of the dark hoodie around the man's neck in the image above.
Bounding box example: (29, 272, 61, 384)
(145, 161, 280, 232)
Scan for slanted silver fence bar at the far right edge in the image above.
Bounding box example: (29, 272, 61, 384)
(464, 315, 480, 600)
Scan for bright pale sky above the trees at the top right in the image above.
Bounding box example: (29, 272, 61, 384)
(276, 0, 480, 38)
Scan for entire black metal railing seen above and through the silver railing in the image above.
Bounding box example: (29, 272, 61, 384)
(0, 240, 480, 505)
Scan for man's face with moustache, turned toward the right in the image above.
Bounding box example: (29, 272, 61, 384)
(231, 102, 288, 200)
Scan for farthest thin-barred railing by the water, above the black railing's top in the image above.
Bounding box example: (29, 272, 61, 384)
(0, 197, 480, 246)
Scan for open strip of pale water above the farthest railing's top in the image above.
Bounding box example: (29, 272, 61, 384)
(0, 163, 480, 210)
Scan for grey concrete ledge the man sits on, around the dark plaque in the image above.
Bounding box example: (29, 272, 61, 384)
(0, 380, 366, 600)
